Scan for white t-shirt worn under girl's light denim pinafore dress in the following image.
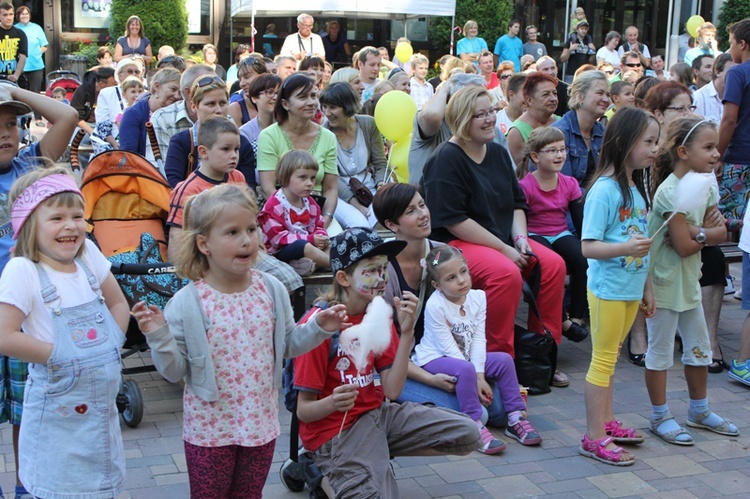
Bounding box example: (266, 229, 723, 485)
(0, 239, 111, 343)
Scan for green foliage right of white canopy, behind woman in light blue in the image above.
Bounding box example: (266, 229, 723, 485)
(429, 0, 513, 54)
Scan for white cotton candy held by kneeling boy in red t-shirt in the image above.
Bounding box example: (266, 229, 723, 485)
(339, 296, 393, 372)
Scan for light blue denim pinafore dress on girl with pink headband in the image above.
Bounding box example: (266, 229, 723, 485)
(19, 260, 125, 499)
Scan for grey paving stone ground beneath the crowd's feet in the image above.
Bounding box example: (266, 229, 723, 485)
(0, 265, 750, 499)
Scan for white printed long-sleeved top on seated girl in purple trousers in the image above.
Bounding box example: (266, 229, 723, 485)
(412, 289, 487, 373)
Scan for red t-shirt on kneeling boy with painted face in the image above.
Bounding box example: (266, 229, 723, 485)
(294, 309, 398, 451)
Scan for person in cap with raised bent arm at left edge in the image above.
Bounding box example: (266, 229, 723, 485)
(0, 83, 78, 497)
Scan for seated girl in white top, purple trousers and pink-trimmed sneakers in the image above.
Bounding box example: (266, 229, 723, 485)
(412, 246, 542, 454)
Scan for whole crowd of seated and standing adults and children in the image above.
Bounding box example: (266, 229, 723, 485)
(0, 4, 750, 497)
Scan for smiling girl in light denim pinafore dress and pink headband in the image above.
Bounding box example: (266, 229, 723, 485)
(0, 168, 129, 499)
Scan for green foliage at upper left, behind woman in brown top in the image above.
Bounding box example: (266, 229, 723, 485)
(109, 0, 188, 55)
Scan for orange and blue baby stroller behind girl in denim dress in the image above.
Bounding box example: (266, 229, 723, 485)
(76, 146, 183, 428)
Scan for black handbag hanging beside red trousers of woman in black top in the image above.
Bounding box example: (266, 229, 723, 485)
(515, 254, 557, 395)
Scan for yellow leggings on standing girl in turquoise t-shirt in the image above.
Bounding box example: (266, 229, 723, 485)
(586, 290, 640, 388)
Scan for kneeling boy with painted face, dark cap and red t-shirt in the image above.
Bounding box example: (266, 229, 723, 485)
(294, 228, 482, 497)
